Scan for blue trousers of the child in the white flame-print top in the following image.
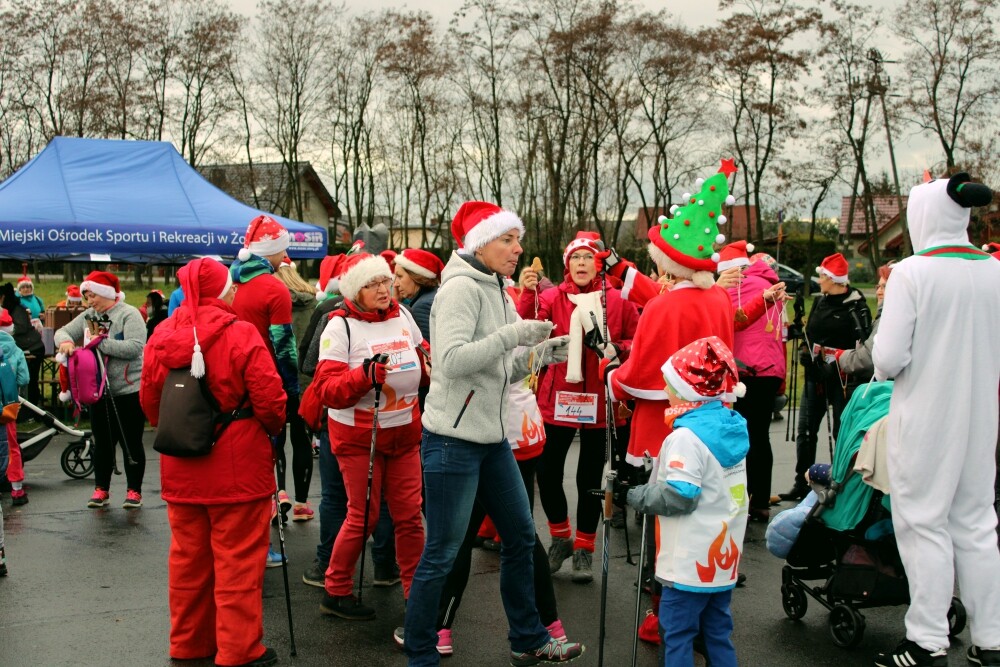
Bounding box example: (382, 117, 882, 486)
(660, 586, 736, 667)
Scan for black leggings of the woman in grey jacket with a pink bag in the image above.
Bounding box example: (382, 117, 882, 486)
(90, 391, 146, 493)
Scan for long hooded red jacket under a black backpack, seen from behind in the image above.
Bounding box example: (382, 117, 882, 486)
(139, 298, 285, 504)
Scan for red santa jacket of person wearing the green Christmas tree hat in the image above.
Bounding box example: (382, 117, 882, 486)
(608, 282, 735, 465)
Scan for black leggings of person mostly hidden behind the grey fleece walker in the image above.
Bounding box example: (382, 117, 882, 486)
(437, 458, 559, 629)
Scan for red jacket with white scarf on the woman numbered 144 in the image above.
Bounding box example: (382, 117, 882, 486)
(517, 279, 639, 428)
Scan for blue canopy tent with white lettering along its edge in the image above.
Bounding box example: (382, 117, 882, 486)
(0, 137, 327, 264)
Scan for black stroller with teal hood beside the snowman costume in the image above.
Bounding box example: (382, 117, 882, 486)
(776, 382, 967, 648)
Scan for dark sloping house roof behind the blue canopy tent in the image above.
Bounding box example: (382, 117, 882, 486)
(198, 162, 340, 218)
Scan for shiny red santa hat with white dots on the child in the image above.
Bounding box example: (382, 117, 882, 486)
(660, 336, 746, 403)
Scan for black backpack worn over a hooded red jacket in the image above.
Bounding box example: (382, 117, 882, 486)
(153, 367, 253, 458)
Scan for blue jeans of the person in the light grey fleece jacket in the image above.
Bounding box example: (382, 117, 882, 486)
(404, 429, 549, 667)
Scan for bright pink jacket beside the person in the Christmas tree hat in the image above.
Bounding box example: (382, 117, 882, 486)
(726, 262, 785, 378)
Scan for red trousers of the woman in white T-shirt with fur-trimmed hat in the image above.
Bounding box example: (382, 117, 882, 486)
(326, 445, 424, 598)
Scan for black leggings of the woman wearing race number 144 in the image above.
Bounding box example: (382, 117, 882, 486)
(538, 423, 605, 533)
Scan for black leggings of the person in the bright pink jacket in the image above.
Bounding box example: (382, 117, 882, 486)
(733, 377, 781, 510)
